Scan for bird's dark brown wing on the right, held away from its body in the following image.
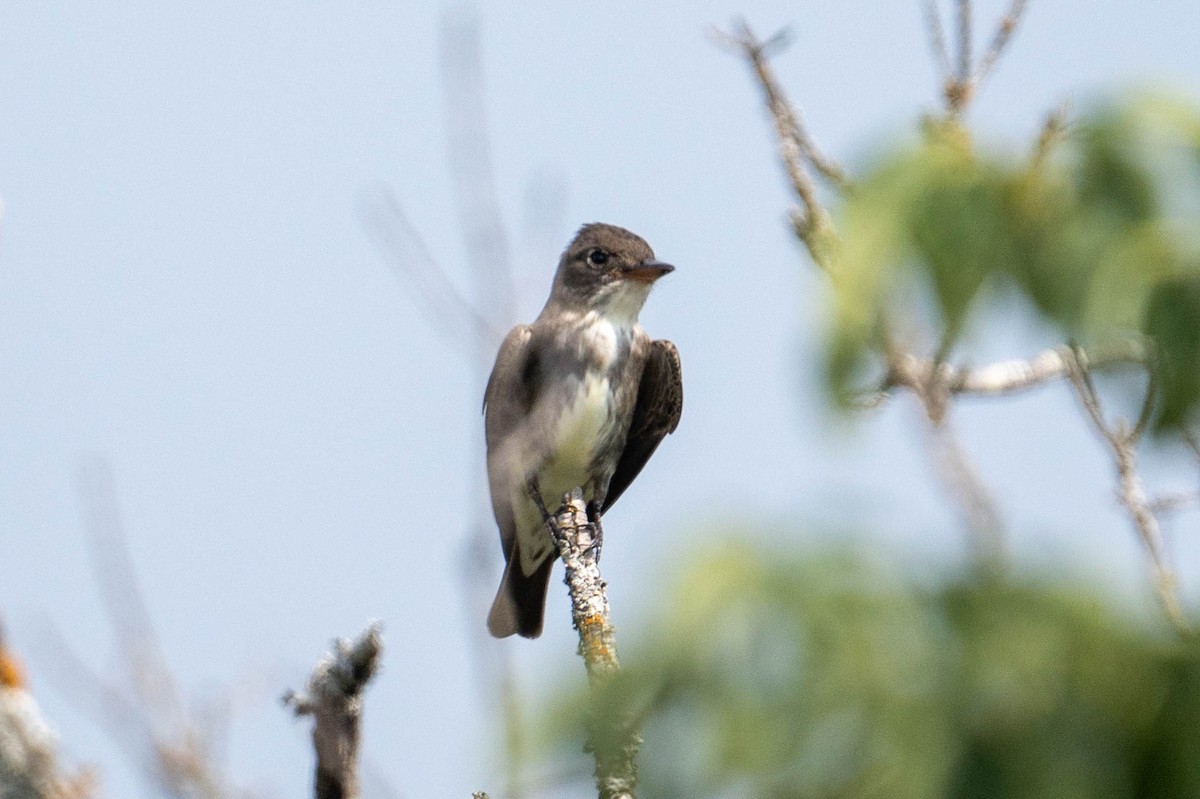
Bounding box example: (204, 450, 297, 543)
(600, 340, 683, 513)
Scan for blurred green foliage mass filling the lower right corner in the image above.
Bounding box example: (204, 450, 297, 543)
(547, 546, 1200, 799)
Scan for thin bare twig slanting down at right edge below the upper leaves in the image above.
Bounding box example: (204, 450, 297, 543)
(1068, 348, 1190, 633)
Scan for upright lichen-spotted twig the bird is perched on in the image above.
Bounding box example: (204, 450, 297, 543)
(529, 487, 642, 799)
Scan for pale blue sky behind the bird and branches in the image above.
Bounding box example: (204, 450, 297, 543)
(0, 0, 1200, 797)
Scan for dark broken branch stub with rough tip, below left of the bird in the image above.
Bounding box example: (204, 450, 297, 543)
(283, 623, 383, 799)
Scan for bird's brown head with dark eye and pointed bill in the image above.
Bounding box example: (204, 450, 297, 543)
(550, 223, 674, 323)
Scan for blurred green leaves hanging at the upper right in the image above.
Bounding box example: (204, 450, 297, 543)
(827, 96, 1200, 431)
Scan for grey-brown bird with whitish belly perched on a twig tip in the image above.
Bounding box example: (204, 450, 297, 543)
(484, 224, 683, 638)
